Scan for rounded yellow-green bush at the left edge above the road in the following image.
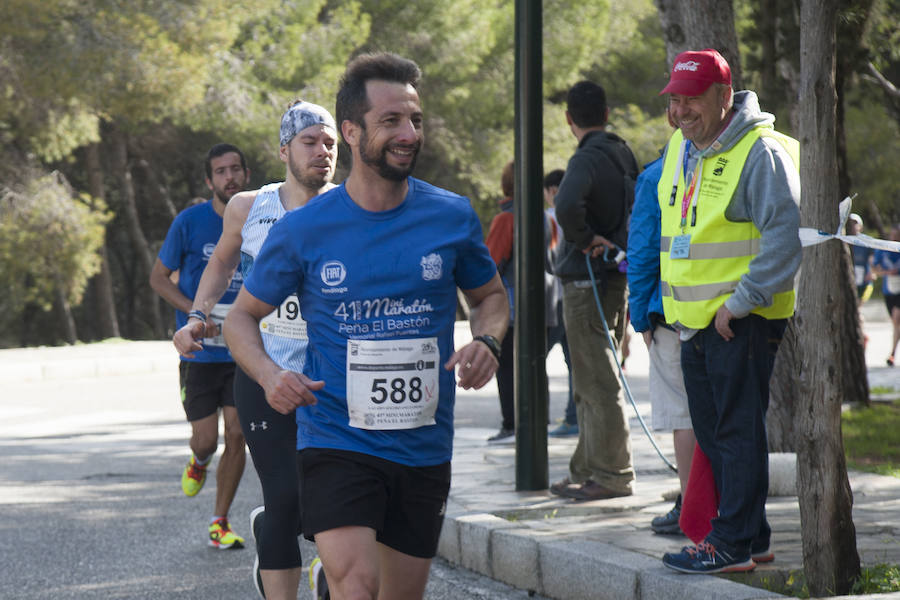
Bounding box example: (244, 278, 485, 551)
(0, 173, 109, 315)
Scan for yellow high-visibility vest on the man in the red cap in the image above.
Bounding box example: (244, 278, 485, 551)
(657, 127, 800, 329)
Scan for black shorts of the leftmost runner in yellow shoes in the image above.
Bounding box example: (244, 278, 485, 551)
(178, 360, 234, 421)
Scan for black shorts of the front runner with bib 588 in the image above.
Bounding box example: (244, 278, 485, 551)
(297, 448, 450, 558)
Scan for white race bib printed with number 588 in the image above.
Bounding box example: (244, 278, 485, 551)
(347, 337, 441, 430)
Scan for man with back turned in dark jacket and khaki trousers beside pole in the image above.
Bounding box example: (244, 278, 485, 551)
(550, 81, 638, 500)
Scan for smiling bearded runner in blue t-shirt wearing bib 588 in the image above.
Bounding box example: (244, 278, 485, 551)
(225, 54, 509, 599)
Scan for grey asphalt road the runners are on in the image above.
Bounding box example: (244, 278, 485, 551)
(0, 360, 565, 600)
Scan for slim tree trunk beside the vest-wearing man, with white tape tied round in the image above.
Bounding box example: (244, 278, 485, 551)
(794, 0, 860, 596)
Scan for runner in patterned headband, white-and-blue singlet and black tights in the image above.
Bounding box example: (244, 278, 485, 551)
(172, 100, 337, 600)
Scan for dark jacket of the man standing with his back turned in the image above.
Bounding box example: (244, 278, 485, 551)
(554, 131, 639, 281)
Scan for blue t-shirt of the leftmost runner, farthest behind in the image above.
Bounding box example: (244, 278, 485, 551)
(159, 200, 243, 362)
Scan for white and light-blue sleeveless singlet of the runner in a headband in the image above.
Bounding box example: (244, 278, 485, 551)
(241, 182, 306, 372)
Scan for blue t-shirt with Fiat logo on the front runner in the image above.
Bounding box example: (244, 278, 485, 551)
(246, 178, 497, 466)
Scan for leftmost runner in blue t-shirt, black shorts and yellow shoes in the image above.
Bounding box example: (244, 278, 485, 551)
(150, 144, 250, 549)
